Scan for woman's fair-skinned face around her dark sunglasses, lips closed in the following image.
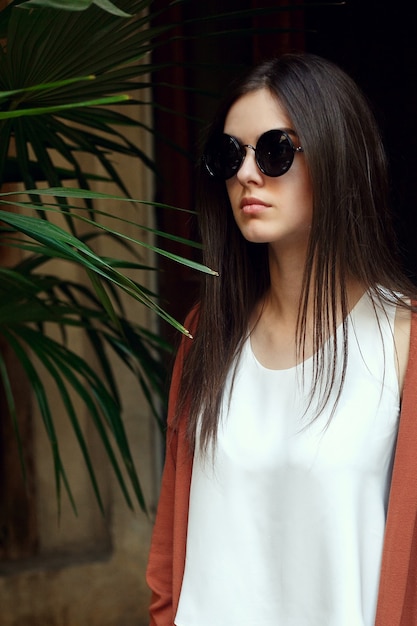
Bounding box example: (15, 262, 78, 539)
(224, 89, 313, 254)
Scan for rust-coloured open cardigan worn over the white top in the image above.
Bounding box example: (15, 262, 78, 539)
(147, 316, 417, 626)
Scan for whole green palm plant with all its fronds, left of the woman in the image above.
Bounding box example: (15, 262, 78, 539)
(0, 0, 308, 509)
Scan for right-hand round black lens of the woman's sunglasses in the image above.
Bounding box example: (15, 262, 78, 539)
(256, 130, 294, 176)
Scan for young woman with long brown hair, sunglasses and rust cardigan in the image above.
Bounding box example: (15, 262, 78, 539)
(148, 55, 417, 626)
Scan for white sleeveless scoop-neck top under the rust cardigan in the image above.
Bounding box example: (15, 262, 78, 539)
(175, 294, 399, 626)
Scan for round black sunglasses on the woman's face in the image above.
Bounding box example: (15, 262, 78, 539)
(203, 129, 303, 180)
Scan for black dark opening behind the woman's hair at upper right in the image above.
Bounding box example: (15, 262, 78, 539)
(305, 0, 417, 283)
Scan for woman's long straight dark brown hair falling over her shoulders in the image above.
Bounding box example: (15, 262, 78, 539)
(177, 54, 414, 450)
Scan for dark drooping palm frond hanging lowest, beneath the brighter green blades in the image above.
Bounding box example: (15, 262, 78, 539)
(0, 255, 171, 510)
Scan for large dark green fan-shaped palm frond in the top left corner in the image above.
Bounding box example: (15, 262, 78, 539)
(0, 0, 169, 201)
